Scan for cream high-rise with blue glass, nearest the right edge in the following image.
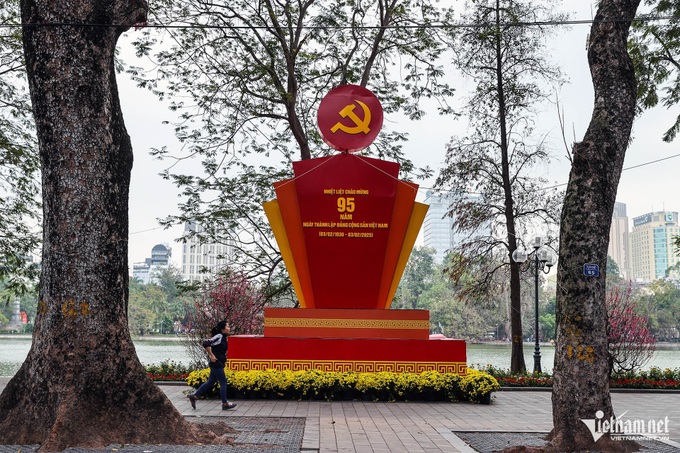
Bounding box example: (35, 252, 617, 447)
(630, 211, 680, 282)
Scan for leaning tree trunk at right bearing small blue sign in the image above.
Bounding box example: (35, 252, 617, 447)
(552, 0, 640, 451)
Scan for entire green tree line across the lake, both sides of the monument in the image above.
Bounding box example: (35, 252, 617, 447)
(0, 247, 680, 342)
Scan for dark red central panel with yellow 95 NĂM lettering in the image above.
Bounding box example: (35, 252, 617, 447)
(293, 154, 402, 308)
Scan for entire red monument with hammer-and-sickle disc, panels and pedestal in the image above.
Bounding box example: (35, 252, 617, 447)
(229, 85, 466, 374)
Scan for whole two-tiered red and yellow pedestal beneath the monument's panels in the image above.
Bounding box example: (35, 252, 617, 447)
(229, 308, 467, 374)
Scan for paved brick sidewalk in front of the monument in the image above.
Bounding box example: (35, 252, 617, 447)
(0, 378, 680, 453)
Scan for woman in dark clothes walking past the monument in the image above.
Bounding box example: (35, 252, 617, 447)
(189, 321, 236, 410)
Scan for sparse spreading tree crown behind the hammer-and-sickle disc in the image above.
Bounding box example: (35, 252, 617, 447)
(130, 0, 453, 289)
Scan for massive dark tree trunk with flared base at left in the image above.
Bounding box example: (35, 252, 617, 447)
(0, 0, 231, 451)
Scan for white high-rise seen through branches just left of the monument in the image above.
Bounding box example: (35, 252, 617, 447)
(182, 222, 233, 281)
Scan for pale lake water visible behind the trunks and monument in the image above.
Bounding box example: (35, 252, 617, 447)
(0, 335, 680, 376)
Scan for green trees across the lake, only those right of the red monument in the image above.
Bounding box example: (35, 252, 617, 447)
(392, 247, 680, 342)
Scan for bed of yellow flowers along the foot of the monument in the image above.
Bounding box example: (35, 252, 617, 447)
(186, 369, 500, 404)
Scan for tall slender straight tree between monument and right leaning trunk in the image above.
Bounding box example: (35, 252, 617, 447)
(436, 0, 561, 371)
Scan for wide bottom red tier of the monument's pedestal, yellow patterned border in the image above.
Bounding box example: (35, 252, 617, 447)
(228, 335, 467, 375)
